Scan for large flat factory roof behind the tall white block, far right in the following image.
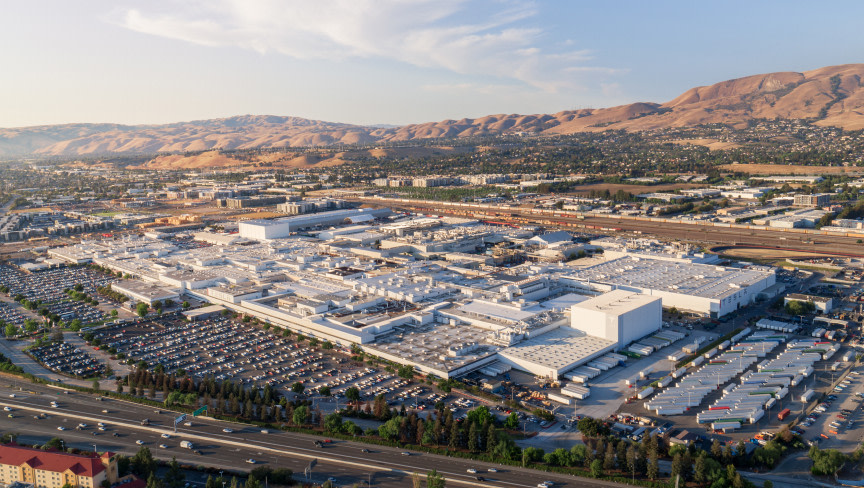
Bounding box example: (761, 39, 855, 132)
(572, 257, 774, 298)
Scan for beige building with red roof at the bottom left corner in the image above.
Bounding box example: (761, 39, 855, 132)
(0, 445, 118, 488)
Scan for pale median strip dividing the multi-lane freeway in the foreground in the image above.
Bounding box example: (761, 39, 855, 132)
(0, 402, 531, 488)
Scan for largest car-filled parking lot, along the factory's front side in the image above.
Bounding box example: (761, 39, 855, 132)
(95, 314, 486, 412)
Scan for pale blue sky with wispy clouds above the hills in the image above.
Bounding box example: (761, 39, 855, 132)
(0, 0, 864, 127)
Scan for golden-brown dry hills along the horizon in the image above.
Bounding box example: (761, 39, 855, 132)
(0, 64, 864, 157)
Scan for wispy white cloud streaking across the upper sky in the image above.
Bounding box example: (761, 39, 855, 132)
(117, 0, 615, 93)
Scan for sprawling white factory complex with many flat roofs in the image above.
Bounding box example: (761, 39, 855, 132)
(48, 209, 775, 379)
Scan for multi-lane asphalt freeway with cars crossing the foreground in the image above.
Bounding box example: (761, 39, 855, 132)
(0, 376, 616, 488)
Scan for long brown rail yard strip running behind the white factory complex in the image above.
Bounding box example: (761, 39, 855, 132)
(354, 198, 864, 257)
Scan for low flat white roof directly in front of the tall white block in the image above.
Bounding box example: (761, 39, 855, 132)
(499, 327, 617, 371)
